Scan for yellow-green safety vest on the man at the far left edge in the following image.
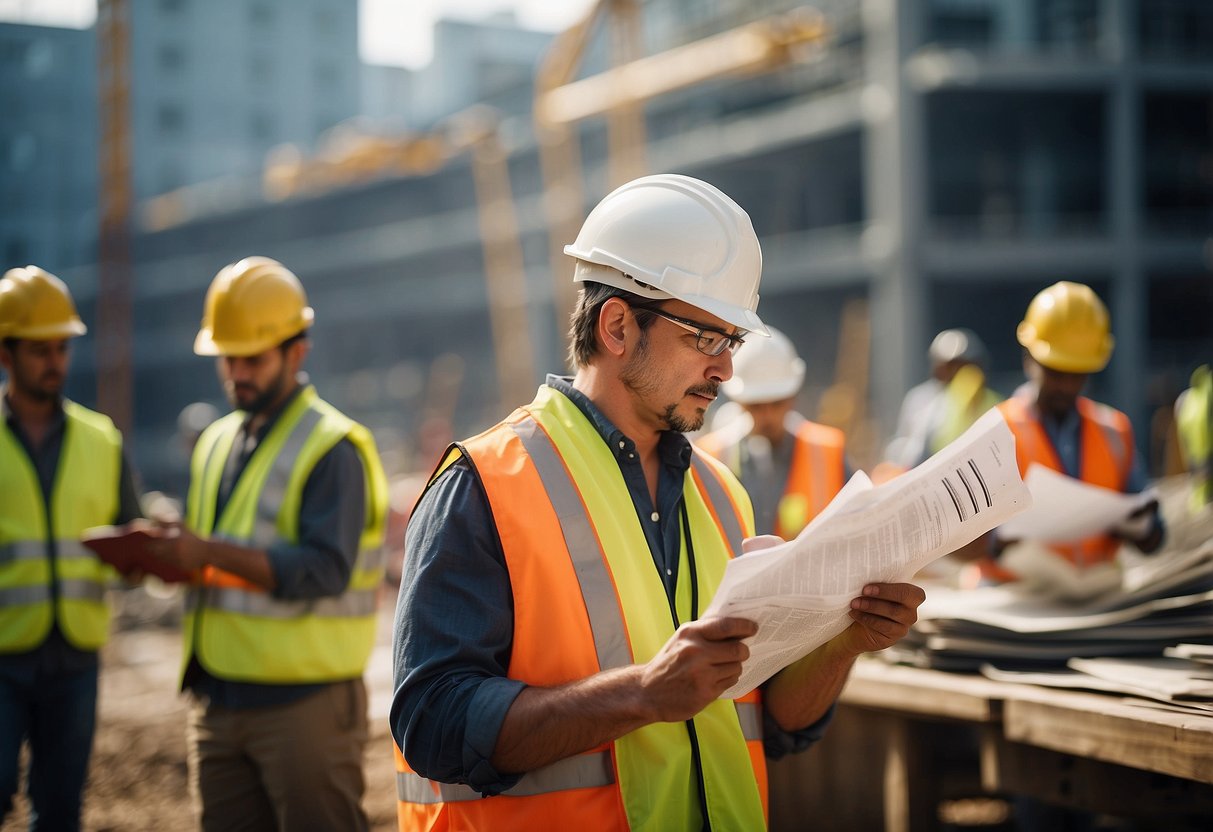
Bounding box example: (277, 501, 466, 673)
(0, 400, 123, 653)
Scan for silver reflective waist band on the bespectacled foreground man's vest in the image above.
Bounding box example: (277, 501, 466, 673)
(395, 702, 762, 804)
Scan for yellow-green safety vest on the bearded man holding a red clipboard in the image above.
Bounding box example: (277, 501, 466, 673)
(184, 387, 387, 684)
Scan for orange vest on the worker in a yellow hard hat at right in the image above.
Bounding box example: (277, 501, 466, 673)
(980, 397, 1133, 581)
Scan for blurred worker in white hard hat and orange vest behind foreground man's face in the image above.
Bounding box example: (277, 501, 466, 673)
(697, 327, 850, 540)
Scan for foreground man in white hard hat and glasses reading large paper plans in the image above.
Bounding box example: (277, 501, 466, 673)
(391, 175, 923, 830)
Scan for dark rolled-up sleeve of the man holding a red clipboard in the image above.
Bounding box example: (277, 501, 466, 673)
(267, 439, 366, 600)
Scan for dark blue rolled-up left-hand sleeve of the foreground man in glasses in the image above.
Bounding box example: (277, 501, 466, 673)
(389, 461, 525, 794)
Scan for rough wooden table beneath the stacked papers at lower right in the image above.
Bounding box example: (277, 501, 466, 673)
(770, 660, 1213, 832)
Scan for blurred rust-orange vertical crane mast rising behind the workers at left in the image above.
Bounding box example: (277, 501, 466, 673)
(96, 0, 135, 431)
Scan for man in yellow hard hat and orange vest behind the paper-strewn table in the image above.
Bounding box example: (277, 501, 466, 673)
(969, 280, 1163, 582)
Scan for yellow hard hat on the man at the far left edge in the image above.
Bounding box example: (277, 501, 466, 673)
(0, 266, 89, 341)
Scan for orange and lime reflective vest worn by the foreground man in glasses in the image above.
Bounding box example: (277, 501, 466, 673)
(395, 387, 767, 832)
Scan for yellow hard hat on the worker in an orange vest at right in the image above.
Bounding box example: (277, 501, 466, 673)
(1015, 280, 1116, 372)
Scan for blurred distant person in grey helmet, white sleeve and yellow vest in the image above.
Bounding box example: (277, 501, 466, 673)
(881, 329, 1002, 479)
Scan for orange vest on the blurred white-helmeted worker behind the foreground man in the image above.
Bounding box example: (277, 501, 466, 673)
(699, 421, 847, 540)
